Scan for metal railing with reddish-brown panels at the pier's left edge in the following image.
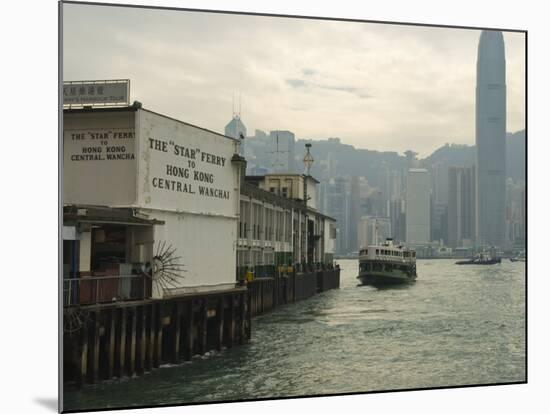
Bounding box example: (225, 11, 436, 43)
(63, 275, 151, 306)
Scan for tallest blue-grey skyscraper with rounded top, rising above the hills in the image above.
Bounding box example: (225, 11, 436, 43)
(476, 30, 506, 246)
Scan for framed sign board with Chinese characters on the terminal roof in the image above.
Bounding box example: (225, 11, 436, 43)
(63, 79, 130, 106)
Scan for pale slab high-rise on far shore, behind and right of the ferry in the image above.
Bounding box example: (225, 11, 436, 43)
(405, 168, 430, 244)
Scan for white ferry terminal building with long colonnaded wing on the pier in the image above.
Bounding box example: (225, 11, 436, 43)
(63, 105, 335, 304)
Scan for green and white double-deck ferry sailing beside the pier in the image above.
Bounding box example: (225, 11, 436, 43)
(357, 238, 416, 286)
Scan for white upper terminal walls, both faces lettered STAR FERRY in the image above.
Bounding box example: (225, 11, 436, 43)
(63, 108, 239, 218)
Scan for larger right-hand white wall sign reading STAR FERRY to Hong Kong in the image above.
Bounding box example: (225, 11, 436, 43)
(138, 110, 237, 217)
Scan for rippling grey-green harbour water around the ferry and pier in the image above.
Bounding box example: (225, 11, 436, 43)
(64, 260, 526, 410)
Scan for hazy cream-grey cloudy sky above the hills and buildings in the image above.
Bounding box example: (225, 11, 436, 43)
(63, 4, 525, 156)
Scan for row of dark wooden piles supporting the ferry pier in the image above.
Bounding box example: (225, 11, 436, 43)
(63, 269, 340, 385)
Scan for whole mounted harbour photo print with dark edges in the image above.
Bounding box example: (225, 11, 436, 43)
(59, 1, 527, 412)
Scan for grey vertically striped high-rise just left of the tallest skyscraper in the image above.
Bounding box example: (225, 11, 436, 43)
(447, 167, 476, 247)
